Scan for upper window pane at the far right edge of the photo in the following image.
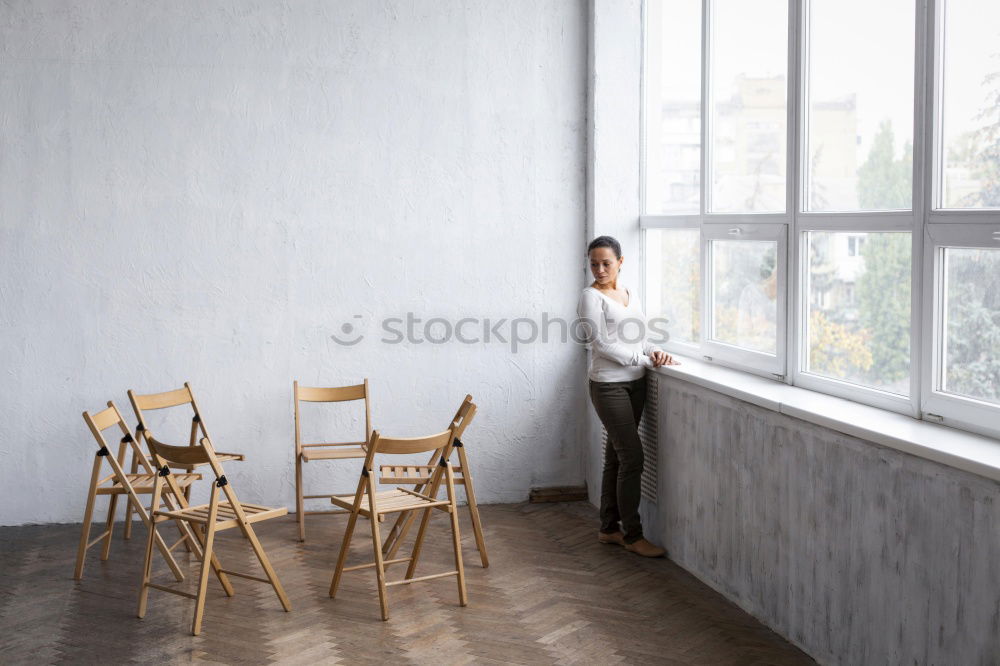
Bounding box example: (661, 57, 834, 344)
(938, 0, 1000, 208)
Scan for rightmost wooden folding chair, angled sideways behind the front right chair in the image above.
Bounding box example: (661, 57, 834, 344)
(380, 395, 490, 568)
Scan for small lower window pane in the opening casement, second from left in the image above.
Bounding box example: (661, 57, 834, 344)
(712, 241, 778, 354)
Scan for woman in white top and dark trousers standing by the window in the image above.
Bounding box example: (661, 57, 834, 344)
(577, 236, 677, 557)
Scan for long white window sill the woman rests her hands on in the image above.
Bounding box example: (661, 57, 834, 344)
(652, 356, 1000, 481)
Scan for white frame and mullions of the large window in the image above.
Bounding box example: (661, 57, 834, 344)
(639, 0, 1000, 438)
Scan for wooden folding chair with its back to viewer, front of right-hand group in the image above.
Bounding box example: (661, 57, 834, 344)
(330, 428, 468, 620)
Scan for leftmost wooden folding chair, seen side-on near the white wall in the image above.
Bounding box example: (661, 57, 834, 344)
(73, 401, 201, 581)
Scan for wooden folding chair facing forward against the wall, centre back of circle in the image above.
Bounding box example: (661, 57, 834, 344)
(292, 379, 372, 541)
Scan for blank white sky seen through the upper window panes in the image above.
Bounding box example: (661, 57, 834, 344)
(653, 0, 1000, 155)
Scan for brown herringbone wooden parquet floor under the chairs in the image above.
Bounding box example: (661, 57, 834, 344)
(0, 503, 813, 665)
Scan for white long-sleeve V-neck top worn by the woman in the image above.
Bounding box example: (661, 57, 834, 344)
(576, 287, 660, 382)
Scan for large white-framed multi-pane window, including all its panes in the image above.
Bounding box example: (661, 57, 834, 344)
(641, 0, 1000, 436)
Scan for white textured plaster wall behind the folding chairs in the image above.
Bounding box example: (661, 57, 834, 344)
(0, 0, 587, 524)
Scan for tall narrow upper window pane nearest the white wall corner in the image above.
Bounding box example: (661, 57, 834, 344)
(645, 0, 701, 214)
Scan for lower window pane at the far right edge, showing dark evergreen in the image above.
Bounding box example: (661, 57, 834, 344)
(941, 248, 1000, 404)
